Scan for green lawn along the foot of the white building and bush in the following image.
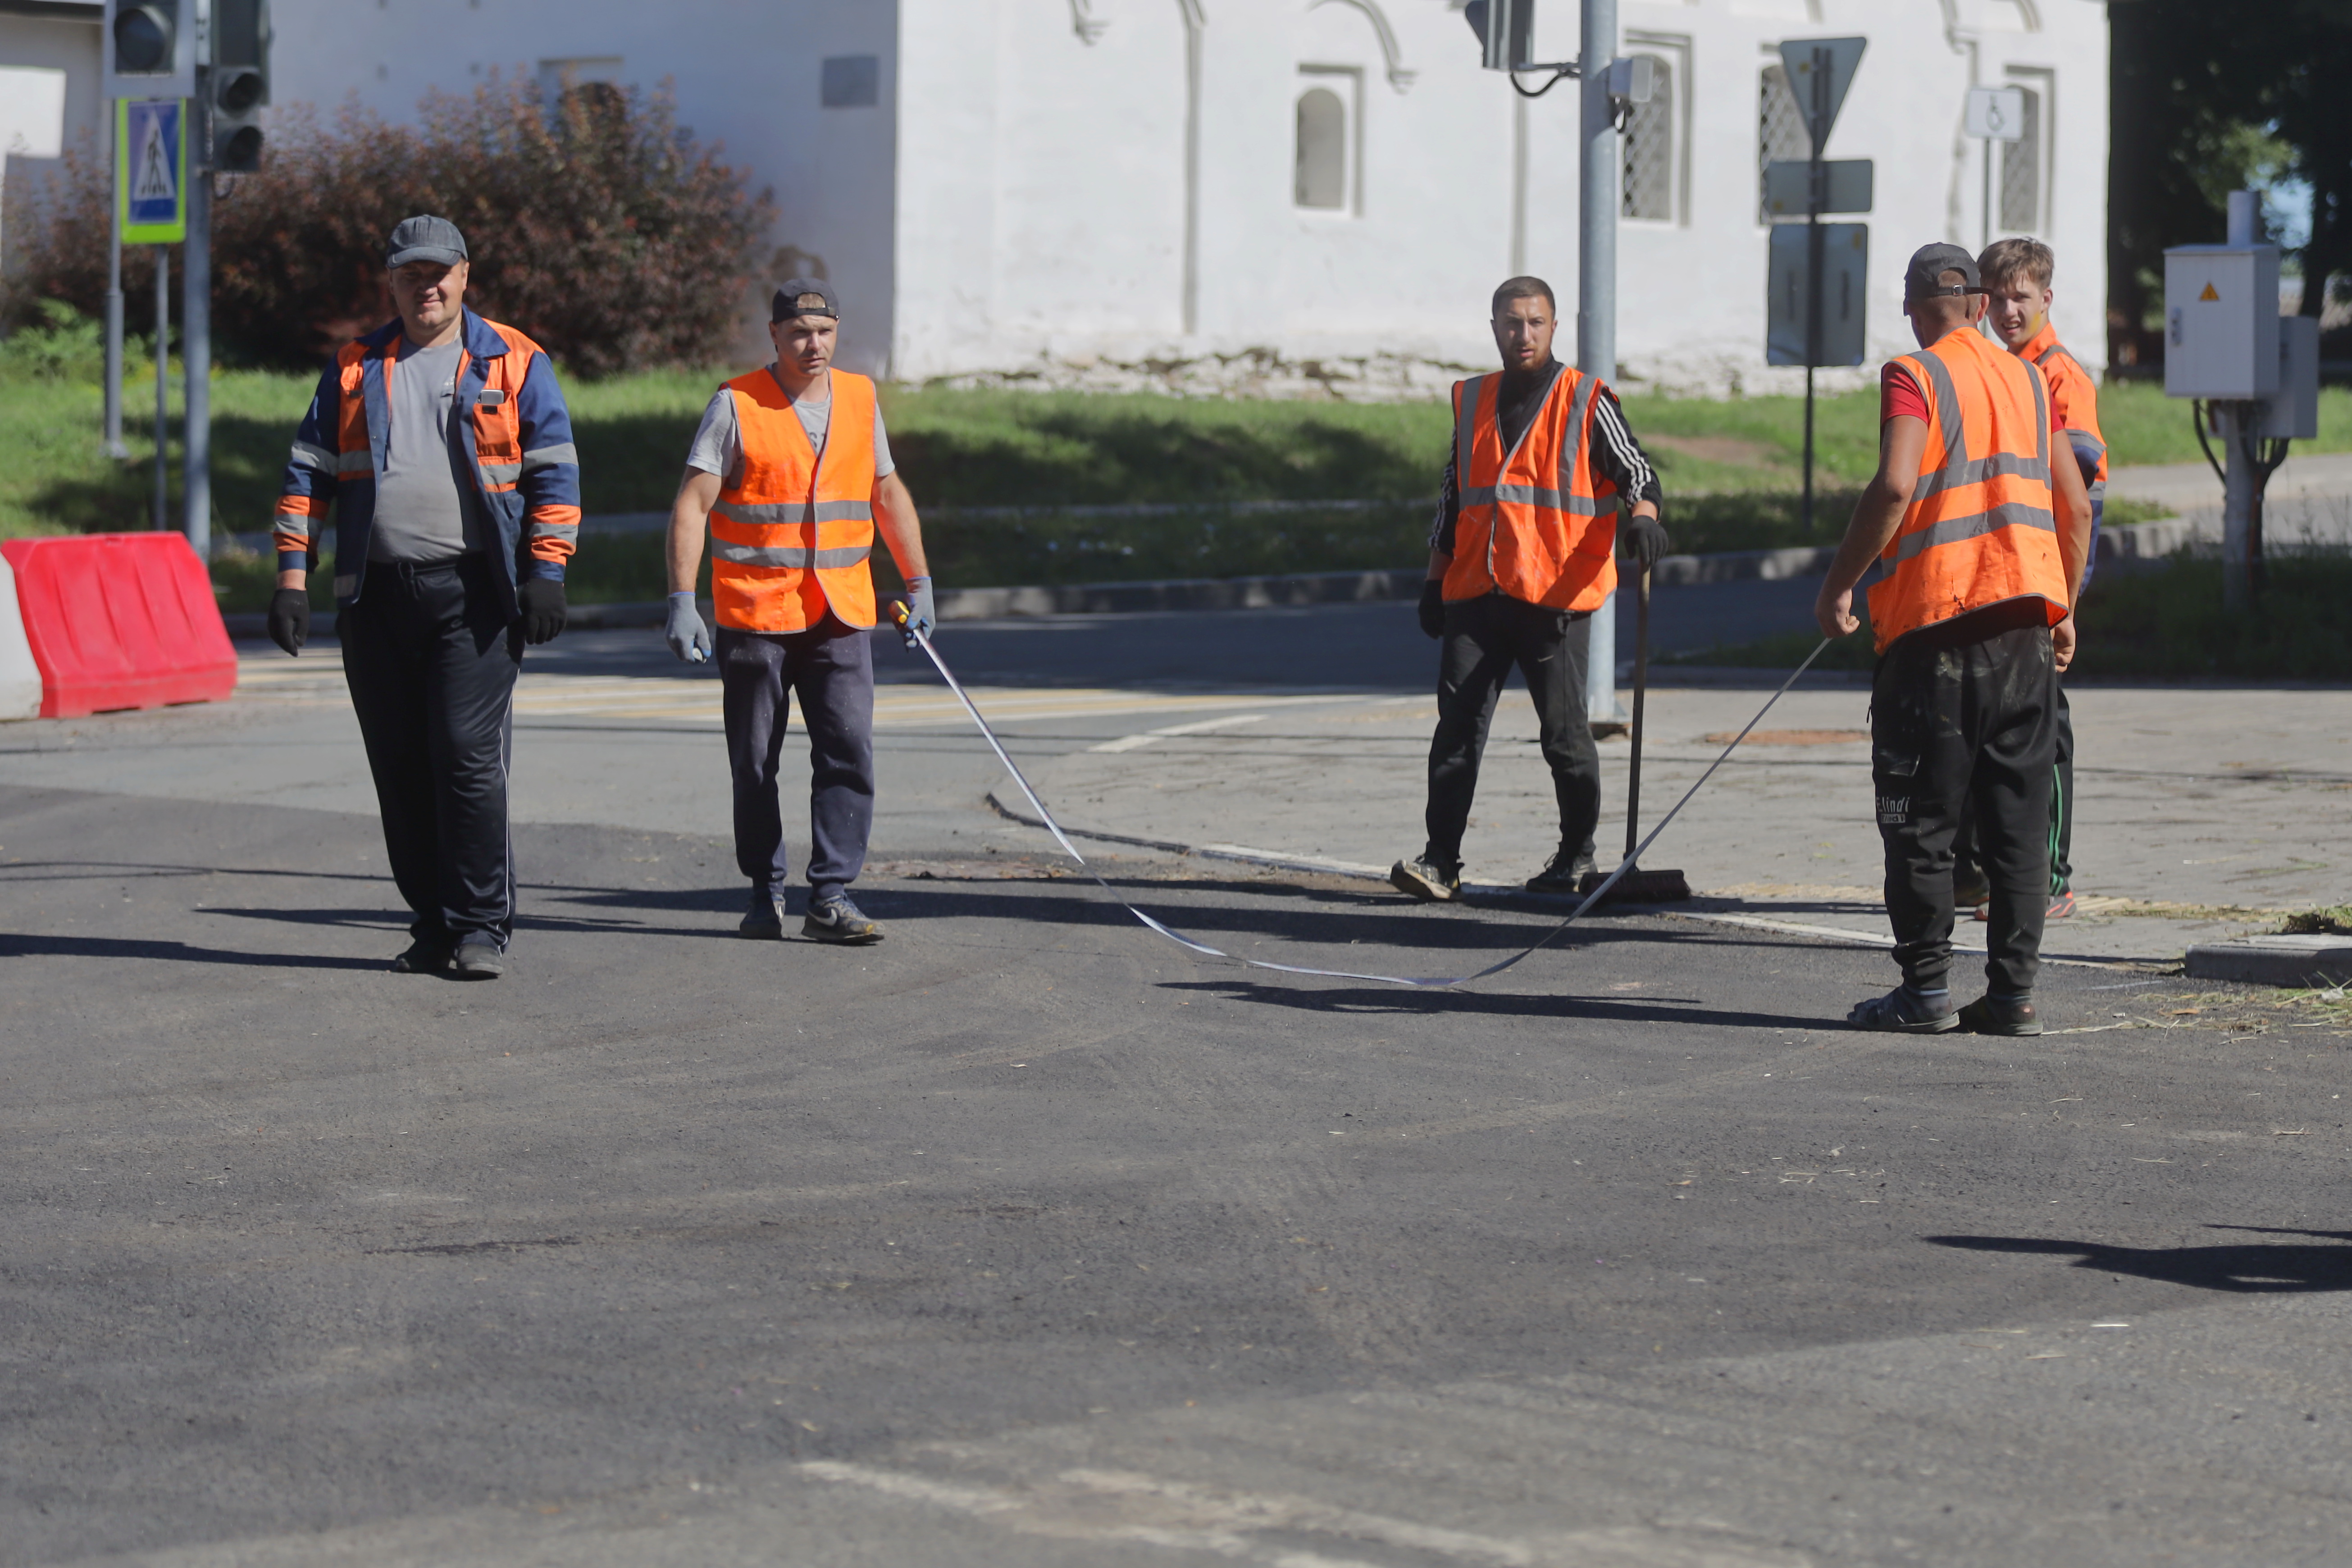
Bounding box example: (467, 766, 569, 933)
(0, 312, 2352, 606)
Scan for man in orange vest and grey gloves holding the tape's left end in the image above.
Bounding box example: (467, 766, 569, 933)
(663, 278, 934, 945)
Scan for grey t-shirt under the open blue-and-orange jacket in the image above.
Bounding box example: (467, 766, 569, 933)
(367, 336, 489, 564)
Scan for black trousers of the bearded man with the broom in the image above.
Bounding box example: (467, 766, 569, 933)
(1423, 593, 1602, 870)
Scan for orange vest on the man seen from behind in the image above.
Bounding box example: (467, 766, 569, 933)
(1870, 327, 2067, 653)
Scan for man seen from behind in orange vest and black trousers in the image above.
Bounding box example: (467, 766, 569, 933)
(1814, 245, 2091, 1035)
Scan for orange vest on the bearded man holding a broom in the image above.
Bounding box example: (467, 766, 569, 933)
(1440, 365, 1616, 609)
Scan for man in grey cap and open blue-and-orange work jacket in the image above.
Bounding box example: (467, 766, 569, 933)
(268, 216, 581, 980)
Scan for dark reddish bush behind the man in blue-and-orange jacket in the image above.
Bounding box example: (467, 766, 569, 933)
(12, 75, 774, 376)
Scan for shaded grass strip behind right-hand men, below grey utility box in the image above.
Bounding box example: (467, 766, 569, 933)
(1663, 550, 2352, 682)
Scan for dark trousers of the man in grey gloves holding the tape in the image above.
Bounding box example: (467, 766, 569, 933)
(717, 614, 875, 898)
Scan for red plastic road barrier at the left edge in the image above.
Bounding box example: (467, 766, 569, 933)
(0, 533, 237, 720)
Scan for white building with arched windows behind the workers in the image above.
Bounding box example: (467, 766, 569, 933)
(14, 0, 2107, 397)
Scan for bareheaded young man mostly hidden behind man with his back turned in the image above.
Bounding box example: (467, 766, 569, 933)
(1952, 240, 2107, 919)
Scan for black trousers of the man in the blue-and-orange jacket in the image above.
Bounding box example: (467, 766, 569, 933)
(334, 555, 522, 950)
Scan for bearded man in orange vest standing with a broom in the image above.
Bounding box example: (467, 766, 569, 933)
(1388, 278, 1665, 898)
